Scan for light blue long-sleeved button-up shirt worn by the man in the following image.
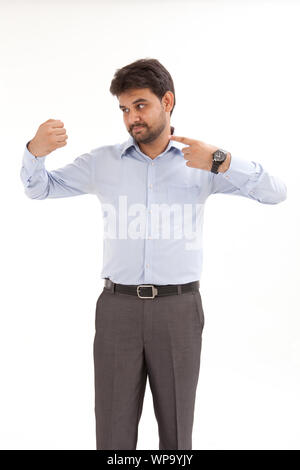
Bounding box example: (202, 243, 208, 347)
(20, 126, 287, 285)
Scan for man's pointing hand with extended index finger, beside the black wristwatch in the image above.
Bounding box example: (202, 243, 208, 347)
(169, 135, 231, 173)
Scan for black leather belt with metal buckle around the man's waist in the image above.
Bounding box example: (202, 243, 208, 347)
(104, 278, 200, 299)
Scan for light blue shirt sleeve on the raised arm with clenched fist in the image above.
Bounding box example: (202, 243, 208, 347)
(20, 142, 94, 199)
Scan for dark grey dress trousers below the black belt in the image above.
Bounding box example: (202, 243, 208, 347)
(94, 280, 204, 450)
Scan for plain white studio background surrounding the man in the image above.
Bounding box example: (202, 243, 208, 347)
(0, 0, 300, 450)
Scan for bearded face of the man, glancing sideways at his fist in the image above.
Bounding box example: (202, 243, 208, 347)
(118, 88, 168, 144)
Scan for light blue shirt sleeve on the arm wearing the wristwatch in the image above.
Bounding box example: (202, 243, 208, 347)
(210, 156, 287, 204)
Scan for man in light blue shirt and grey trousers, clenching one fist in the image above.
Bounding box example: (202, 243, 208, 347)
(21, 59, 286, 450)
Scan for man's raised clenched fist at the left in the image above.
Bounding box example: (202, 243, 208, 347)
(27, 119, 68, 157)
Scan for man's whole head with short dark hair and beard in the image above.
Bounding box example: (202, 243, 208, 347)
(110, 59, 175, 144)
